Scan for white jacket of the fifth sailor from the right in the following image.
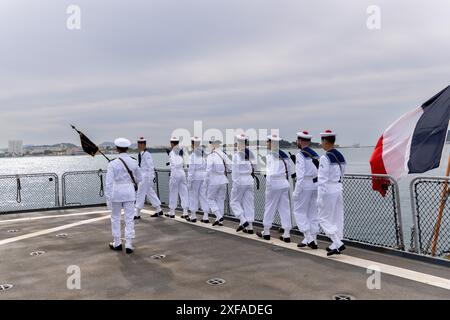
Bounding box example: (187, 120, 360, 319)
(205, 149, 231, 186)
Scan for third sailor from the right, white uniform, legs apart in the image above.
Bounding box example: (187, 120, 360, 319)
(256, 134, 294, 242)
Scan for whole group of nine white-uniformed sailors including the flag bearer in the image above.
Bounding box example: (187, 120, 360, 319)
(105, 130, 346, 256)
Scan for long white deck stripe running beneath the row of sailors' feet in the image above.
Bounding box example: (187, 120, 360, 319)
(141, 209, 450, 290)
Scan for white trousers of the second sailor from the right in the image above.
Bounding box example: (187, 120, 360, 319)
(292, 187, 320, 244)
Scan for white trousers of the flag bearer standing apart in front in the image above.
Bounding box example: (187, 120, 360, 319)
(111, 201, 135, 249)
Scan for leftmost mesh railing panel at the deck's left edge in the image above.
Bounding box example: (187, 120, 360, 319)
(0, 173, 60, 214)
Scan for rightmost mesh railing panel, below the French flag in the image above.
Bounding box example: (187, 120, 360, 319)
(410, 177, 450, 257)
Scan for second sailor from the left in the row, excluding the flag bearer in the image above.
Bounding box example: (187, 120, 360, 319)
(166, 137, 189, 218)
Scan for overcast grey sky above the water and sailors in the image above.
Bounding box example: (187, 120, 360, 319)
(0, 0, 450, 146)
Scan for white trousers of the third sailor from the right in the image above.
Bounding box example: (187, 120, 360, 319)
(263, 188, 292, 238)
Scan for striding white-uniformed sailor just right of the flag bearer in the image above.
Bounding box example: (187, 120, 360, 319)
(134, 137, 163, 219)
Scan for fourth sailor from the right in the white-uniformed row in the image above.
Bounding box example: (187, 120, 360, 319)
(230, 134, 255, 234)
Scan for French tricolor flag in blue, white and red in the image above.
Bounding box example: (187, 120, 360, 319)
(370, 86, 450, 196)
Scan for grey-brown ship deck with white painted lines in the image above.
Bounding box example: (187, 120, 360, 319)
(0, 207, 450, 300)
